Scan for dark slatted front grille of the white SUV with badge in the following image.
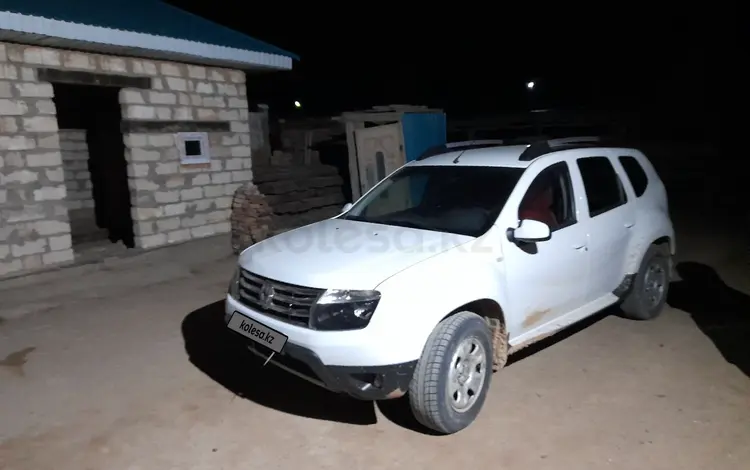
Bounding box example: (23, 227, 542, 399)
(239, 269, 325, 327)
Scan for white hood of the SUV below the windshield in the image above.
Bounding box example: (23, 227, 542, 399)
(239, 219, 473, 289)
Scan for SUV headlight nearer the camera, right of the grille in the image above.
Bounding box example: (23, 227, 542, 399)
(310, 289, 380, 331)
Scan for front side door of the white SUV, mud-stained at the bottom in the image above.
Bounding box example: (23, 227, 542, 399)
(502, 158, 588, 337)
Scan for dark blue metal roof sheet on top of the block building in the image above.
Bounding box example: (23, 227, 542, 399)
(0, 0, 299, 60)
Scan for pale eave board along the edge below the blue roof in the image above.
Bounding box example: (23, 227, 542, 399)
(0, 11, 292, 70)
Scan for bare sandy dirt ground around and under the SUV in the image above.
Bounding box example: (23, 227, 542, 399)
(0, 221, 750, 470)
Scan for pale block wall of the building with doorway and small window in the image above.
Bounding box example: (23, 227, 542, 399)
(0, 43, 252, 276)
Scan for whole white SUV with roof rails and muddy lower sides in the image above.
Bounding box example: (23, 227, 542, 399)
(225, 138, 675, 434)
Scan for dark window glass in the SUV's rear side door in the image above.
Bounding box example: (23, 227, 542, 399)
(578, 157, 627, 217)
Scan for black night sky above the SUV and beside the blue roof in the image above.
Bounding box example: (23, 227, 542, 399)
(169, 0, 744, 124)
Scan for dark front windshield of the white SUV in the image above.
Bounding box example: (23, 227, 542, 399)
(341, 166, 523, 237)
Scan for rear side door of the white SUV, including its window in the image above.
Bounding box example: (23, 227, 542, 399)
(576, 151, 635, 301)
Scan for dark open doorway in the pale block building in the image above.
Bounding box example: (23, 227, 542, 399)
(53, 83, 134, 248)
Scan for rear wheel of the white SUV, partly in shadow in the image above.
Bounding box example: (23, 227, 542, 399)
(620, 245, 672, 320)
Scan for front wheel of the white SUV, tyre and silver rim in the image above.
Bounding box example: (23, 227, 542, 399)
(409, 312, 492, 434)
